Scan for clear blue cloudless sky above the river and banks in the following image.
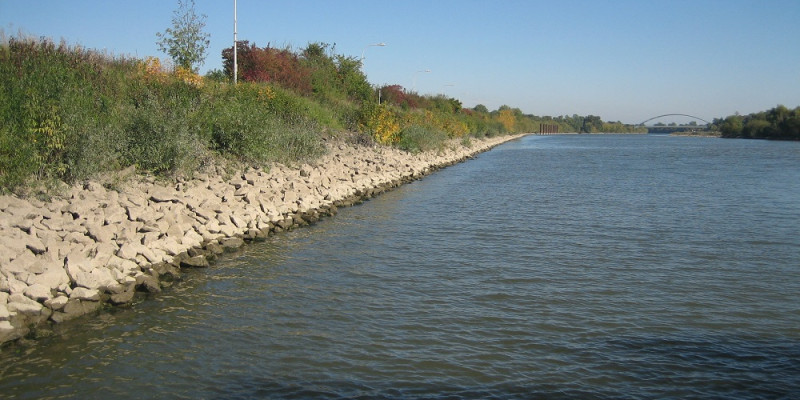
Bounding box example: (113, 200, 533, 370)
(0, 0, 800, 123)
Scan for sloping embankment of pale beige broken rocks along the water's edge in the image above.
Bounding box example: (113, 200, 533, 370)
(0, 136, 515, 343)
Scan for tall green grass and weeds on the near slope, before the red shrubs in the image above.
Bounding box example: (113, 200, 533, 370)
(0, 37, 324, 192)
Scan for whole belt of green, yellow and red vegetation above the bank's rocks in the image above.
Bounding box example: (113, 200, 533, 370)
(0, 30, 648, 193)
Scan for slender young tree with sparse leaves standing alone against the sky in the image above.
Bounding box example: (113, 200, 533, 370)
(156, 0, 211, 72)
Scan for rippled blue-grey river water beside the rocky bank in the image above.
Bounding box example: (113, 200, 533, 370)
(0, 135, 800, 399)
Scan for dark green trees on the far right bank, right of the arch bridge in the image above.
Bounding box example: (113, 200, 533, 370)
(713, 105, 800, 140)
